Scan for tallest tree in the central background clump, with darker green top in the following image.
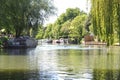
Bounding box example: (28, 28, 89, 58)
(55, 8, 85, 37)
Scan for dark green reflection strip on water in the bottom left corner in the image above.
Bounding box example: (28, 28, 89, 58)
(0, 70, 40, 80)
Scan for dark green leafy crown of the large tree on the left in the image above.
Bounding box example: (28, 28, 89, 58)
(0, 0, 55, 37)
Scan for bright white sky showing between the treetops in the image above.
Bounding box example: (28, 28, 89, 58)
(45, 0, 89, 25)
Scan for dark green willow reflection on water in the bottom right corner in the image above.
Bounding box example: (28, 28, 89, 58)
(93, 69, 120, 80)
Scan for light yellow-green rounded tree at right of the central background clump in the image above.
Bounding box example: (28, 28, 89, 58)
(69, 14, 87, 43)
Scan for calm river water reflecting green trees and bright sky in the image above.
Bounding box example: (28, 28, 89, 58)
(0, 44, 120, 80)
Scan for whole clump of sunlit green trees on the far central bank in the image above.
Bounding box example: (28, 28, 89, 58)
(38, 8, 87, 43)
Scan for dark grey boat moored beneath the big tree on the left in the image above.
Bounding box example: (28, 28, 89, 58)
(3, 37, 38, 49)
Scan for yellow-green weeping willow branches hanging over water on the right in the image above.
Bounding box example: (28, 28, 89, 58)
(91, 0, 120, 46)
